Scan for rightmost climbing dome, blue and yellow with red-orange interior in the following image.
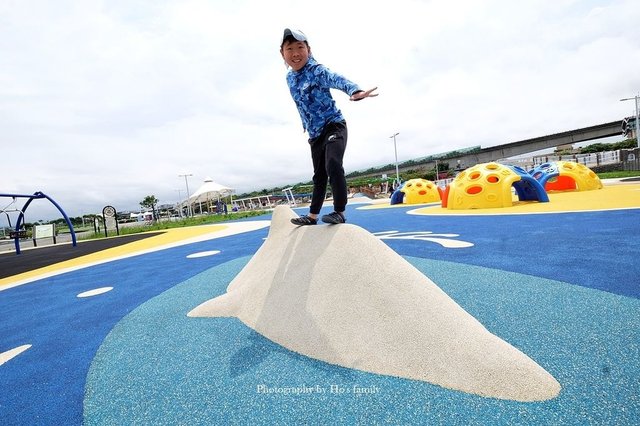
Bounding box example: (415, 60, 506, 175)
(529, 161, 602, 191)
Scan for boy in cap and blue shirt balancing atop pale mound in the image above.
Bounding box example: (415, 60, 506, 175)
(280, 28, 378, 225)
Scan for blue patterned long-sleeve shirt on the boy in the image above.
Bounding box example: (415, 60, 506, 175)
(287, 57, 360, 138)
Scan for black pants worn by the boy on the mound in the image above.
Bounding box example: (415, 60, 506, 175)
(309, 121, 347, 214)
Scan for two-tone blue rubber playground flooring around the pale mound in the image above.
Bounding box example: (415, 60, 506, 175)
(0, 186, 640, 425)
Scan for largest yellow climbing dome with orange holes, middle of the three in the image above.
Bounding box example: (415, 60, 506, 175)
(442, 163, 549, 210)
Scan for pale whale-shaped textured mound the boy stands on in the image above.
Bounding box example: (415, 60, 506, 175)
(188, 206, 560, 401)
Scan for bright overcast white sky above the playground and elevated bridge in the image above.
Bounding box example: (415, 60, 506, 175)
(0, 0, 640, 220)
